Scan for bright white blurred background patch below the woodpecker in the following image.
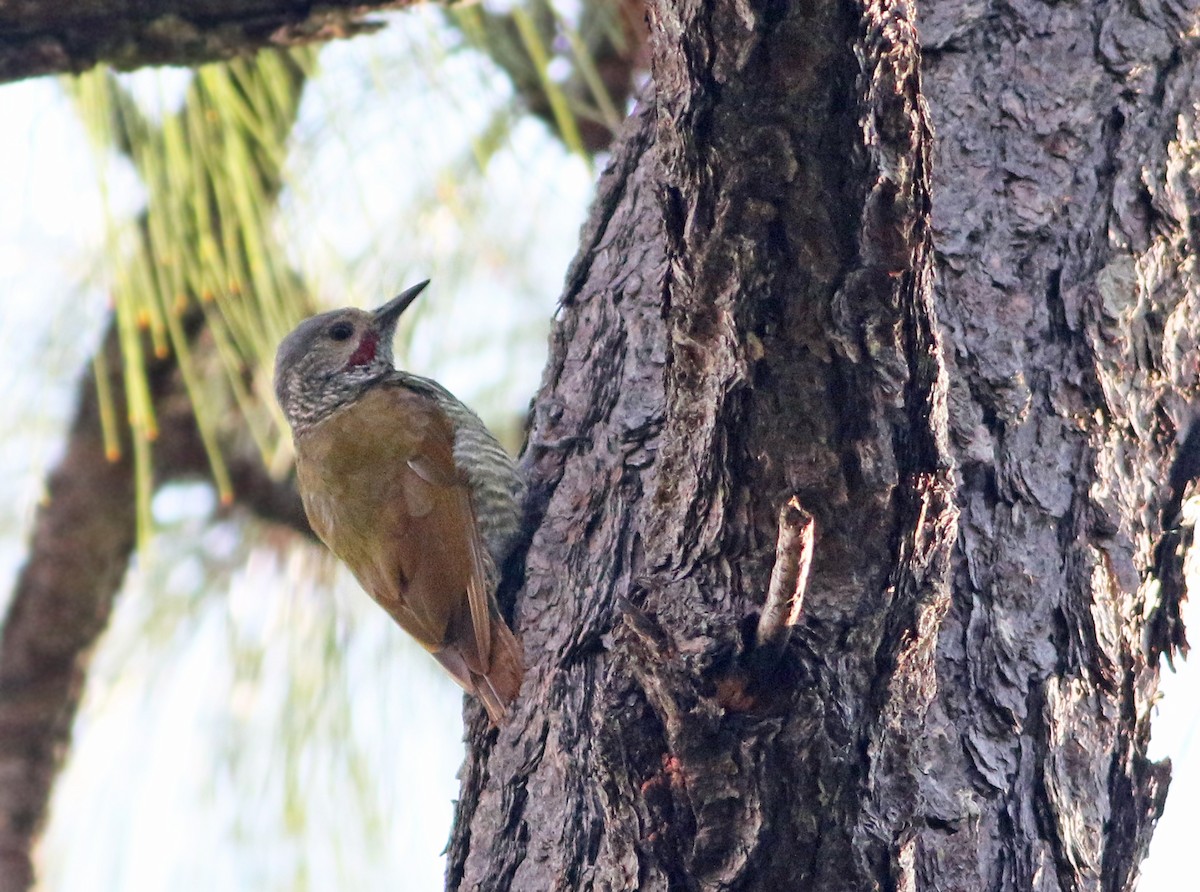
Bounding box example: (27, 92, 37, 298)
(35, 485, 461, 890)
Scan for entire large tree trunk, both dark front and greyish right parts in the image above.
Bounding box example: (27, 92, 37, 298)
(448, 0, 1200, 892)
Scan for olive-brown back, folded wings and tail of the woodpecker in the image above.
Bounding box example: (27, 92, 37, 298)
(296, 385, 523, 722)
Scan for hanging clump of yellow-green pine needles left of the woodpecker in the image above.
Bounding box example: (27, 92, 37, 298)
(66, 49, 316, 545)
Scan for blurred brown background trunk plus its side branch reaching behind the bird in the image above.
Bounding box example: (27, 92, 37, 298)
(0, 317, 314, 892)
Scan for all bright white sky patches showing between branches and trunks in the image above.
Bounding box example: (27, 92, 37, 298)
(0, 13, 1200, 892)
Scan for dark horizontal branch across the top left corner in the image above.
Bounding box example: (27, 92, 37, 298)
(0, 0, 414, 83)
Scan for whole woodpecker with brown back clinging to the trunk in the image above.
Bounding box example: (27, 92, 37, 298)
(275, 280, 524, 725)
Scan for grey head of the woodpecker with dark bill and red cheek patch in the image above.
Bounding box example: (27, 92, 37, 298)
(275, 280, 428, 433)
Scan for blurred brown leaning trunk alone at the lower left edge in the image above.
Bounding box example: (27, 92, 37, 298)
(0, 327, 144, 892)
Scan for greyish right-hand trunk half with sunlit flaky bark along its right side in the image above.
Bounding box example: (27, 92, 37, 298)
(914, 0, 1200, 890)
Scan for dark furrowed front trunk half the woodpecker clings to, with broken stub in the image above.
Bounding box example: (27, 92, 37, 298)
(448, 0, 956, 890)
